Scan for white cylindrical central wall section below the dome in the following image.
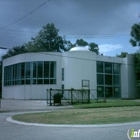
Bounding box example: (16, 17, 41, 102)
(62, 51, 97, 89)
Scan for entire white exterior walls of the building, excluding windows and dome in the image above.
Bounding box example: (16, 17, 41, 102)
(2, 51, 139, 99)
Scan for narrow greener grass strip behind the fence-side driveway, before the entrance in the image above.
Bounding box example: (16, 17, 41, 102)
(74, 99, 140, 108)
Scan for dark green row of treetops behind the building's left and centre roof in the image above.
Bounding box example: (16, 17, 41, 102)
(2, 23, 99, 59)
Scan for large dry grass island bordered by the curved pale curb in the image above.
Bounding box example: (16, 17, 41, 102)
(12, 106, 140, 124)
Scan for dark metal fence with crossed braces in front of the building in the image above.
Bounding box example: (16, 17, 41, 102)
(47, 88, 106, 106)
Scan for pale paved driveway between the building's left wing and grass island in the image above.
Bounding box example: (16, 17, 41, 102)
(0, 99, 73, 112)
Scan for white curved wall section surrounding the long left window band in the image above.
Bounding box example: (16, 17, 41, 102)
(2, 53, 62, 99)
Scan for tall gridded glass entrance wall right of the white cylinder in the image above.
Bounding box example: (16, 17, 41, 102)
(97, 61, 121, 98)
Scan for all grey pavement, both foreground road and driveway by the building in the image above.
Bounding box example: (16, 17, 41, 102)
(0, 100, 140, 140)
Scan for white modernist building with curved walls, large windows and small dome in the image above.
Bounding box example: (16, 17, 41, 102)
(2, 47, 138, 99)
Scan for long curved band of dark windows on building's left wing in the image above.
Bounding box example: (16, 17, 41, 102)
(4, 61, 56, 86)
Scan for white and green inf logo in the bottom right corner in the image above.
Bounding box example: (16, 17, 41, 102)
(127, 128, 140, 140)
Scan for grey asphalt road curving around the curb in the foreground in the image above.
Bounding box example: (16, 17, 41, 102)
(0, 99, 140, 140)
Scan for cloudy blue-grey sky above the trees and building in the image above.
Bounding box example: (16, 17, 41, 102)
(0, 0, 140, 56)
